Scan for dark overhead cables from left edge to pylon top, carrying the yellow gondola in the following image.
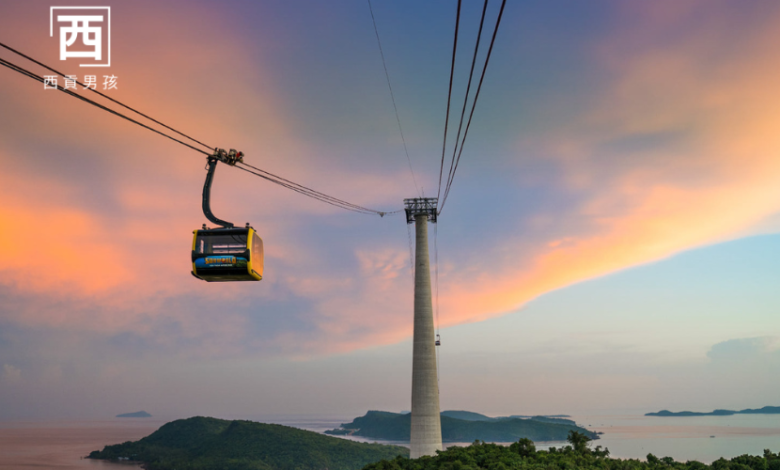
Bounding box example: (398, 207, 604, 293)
(0, 43, 403, 217)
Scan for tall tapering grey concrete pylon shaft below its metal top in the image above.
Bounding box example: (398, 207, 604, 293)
(409, 209, 442, 459)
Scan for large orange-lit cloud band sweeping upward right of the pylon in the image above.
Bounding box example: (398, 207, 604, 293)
(426, 2, 780, 330)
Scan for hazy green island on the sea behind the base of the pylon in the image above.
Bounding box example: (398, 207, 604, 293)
(325, 411, 598, 442)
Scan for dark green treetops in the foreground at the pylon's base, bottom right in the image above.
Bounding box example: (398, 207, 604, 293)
(364, 431, 780, 470)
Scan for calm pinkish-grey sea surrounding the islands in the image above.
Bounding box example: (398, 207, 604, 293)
(0, 414, 780, 470)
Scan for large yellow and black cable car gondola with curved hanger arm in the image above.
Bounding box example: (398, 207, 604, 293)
(192, 149, 263, 282)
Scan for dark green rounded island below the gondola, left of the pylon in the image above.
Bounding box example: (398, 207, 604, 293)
(88, 416, 409, 470)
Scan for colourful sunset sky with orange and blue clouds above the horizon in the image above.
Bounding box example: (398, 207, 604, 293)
(0, 0, 780, 420)
